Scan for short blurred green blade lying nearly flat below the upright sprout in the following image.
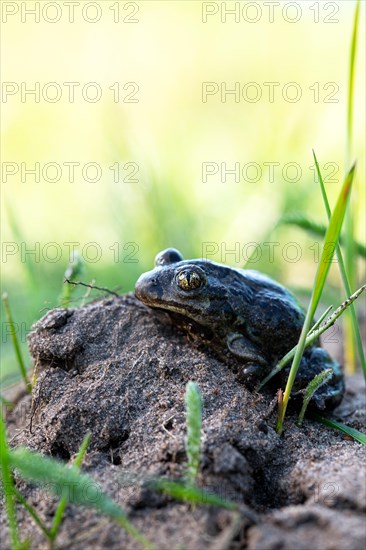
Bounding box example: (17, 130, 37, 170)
(150, 479, 238, 510)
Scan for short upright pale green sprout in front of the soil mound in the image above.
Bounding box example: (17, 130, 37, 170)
(185, 382, 202, 485)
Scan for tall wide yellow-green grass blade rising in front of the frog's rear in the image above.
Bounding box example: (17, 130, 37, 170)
(276, 166, 355, 433)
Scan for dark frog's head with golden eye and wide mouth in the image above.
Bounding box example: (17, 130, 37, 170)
(135, 248, 234, 326)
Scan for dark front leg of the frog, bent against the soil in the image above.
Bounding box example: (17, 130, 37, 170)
(226, 333, 269, 385)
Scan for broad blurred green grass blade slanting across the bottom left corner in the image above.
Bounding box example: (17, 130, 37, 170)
(9, 448, 152, 549)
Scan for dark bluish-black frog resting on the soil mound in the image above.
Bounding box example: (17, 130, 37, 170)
(135, 248, 344, 410)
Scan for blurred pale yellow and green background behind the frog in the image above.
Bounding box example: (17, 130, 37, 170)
(1, 0, 365, 385)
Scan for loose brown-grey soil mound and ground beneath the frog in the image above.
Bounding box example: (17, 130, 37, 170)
(0, 295, 366, 550)
